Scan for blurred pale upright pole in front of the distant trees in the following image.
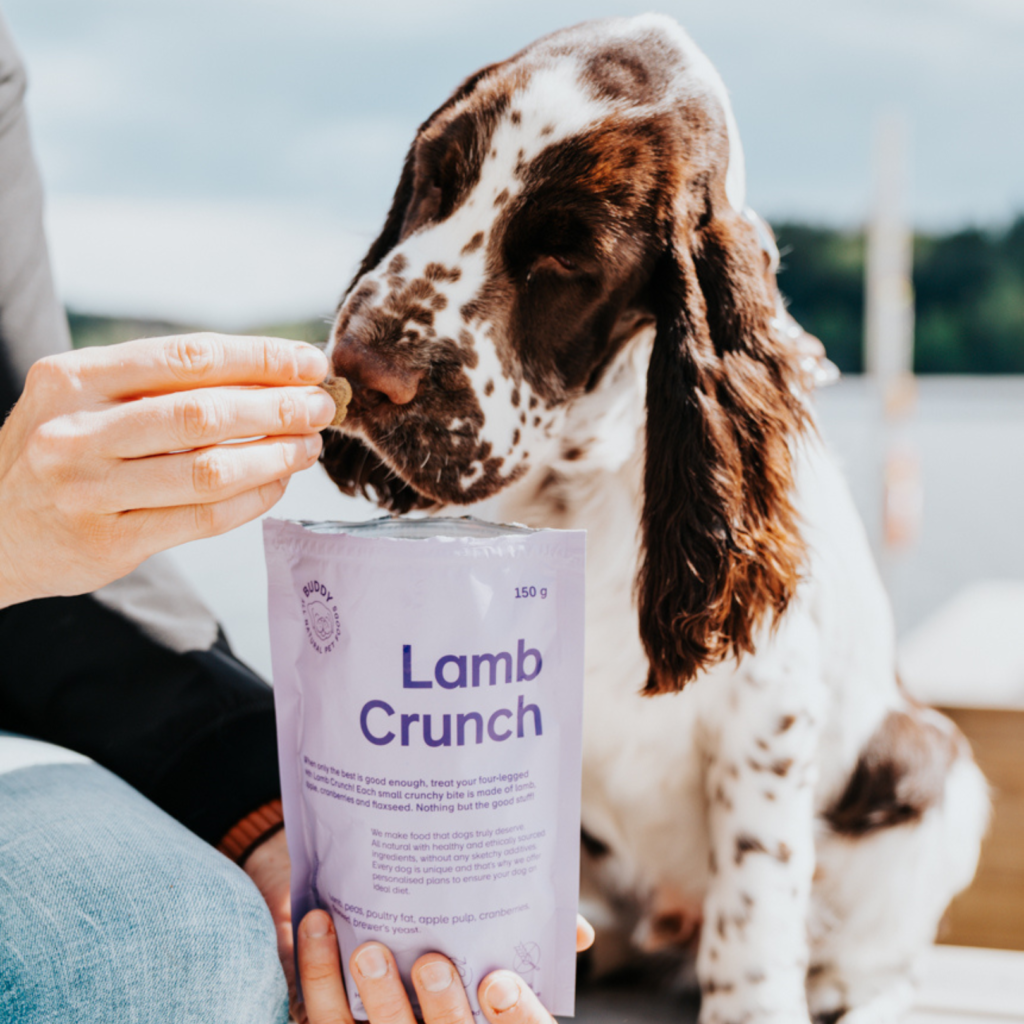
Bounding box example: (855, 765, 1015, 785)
(864, 113, 923, 561)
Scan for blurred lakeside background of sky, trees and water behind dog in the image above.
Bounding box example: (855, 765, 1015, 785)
(0, 0, 1024, 948)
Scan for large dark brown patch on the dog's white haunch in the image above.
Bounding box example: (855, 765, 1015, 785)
(824, 708, 966, 837)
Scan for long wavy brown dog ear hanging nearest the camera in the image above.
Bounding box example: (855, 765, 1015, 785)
(637, 200, 805, 693)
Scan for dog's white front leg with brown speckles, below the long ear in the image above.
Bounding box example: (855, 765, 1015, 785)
(697, 614, 821, 1024)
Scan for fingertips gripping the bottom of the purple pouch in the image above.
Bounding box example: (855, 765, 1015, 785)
(296, 910, 594, 1024)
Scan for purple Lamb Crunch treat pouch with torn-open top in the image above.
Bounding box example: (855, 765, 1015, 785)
(264, 518, 585, 1020)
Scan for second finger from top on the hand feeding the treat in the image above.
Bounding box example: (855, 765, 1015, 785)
(94, 387, 335, 459)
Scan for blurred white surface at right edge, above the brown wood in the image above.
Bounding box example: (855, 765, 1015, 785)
(899, 580, 1024, 708)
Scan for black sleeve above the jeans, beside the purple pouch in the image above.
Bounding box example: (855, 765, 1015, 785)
(0, 596, 281, 843)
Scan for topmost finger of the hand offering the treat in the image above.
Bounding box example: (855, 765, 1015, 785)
(51, 334, 328, 398)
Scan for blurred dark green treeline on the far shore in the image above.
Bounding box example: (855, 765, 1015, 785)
(68, 214, 1024, 374)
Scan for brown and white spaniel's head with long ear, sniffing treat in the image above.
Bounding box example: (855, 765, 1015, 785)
(324, 15, 802, 691)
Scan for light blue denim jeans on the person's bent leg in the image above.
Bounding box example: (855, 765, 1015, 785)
(0, 734, 288, 1024)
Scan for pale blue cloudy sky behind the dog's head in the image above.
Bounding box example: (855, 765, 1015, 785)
(0, 0, 1024, 327)
